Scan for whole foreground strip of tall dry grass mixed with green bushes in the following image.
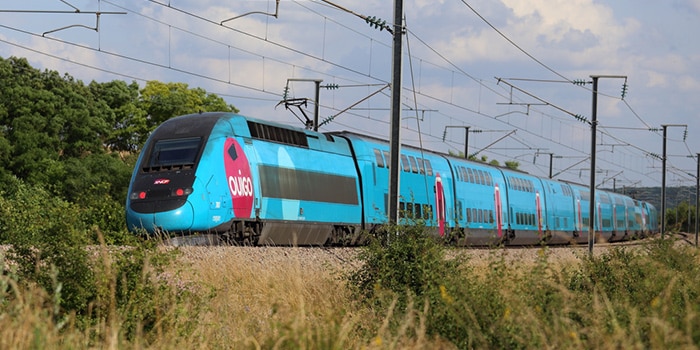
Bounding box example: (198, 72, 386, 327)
(0, 229, 700, 349)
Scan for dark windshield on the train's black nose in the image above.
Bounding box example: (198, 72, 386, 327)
(148, 137, 202, 167)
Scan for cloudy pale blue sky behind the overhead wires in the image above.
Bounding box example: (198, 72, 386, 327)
(0, 0, 700, 189)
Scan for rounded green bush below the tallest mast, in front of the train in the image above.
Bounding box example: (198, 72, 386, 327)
(346, 225, 470, 340)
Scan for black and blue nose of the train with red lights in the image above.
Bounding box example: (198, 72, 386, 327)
(126, 113, 222, 234)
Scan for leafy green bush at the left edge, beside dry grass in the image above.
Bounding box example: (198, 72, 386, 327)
(0, 175, 95, 314)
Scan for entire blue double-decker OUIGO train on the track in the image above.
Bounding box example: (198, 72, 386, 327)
(126, 113, 658, 246)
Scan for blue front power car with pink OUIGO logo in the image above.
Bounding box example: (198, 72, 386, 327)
(127, 113, 362, 245)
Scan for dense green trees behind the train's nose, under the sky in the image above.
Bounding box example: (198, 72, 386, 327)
(0, 57, 237, 244)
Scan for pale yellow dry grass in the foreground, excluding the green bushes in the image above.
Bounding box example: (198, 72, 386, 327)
(0, 241, 700, 349)
